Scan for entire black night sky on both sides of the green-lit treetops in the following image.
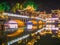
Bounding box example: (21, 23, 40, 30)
(0, 0, 60, 10)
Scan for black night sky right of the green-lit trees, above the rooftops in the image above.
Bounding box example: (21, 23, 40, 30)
(35, 0, 60, 9)
